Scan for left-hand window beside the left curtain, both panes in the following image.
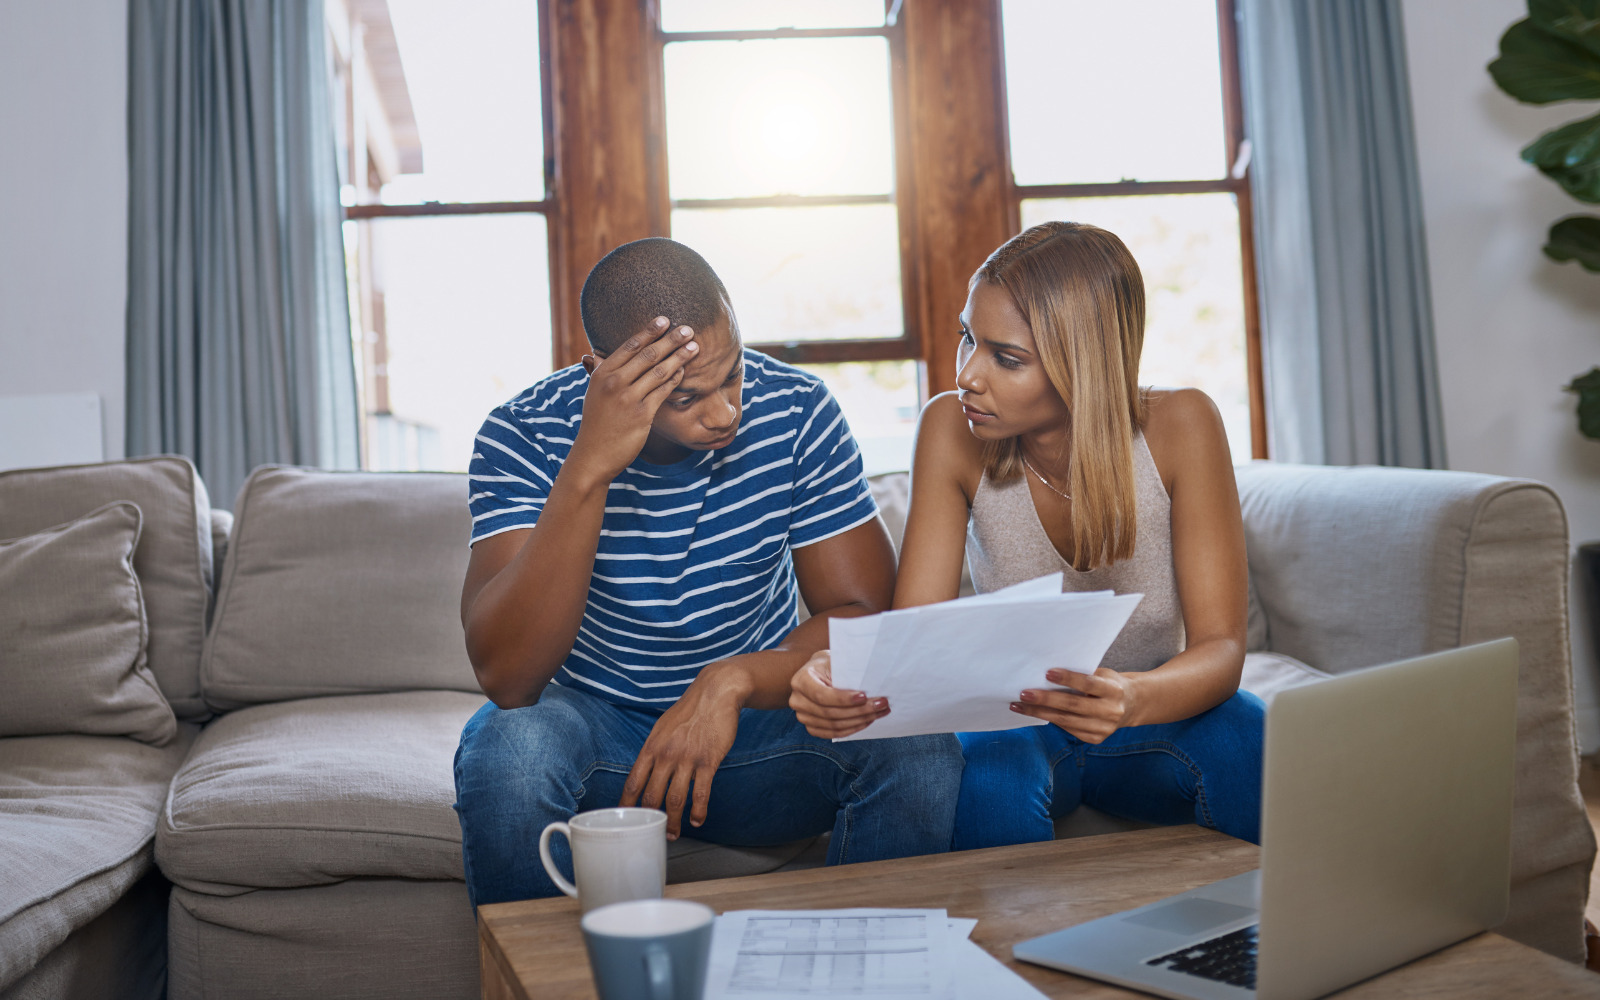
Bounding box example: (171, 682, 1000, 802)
(326, 0, 554, 470)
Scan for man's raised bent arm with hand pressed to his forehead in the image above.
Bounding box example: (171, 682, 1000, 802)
(461, 318, 698, 709)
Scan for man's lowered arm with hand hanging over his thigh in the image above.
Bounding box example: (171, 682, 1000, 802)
(618, 517, 894, 838)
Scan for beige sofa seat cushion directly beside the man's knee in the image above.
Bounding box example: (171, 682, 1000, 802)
(155, 691, 483, 894)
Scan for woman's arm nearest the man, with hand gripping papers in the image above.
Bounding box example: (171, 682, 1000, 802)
(789, 392, 978, 739)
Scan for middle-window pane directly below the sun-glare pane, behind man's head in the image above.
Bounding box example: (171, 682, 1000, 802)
(672, 205, 904, 344)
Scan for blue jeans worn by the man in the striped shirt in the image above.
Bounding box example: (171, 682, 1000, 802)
(456, 685, 962, 906)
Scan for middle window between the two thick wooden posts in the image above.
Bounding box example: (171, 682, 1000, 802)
(654, 0, 922, 472)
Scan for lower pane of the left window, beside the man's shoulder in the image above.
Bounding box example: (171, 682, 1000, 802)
(346, 214, 550, 470)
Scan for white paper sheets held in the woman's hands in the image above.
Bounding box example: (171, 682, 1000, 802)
(827, 573, 1142, 739)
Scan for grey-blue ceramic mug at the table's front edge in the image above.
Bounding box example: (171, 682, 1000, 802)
(582, 899, 717, 1000)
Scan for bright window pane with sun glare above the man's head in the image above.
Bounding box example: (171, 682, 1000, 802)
(664, 38, 894, 198)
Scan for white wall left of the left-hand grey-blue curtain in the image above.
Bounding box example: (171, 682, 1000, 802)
(0, 0, 128, 458)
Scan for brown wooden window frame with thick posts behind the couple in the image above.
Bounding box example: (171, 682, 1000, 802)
(346, 0, 1267, 458)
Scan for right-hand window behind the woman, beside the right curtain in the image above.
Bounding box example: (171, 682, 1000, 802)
(1002, 0, 1266, 461)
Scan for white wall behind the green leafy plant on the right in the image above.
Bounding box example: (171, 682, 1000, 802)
(1403, 0, 1600, 752)
